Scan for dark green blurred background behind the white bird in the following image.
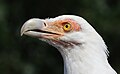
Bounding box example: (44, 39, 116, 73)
(0, 0, 120, 74)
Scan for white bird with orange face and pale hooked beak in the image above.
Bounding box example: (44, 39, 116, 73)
(21, 15, 117, 74)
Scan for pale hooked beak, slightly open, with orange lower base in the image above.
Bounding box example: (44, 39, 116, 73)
(21, 18, 61, 39)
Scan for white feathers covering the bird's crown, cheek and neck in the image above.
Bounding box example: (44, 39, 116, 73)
(47, 15, 117, 74)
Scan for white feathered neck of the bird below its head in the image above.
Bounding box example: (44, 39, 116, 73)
(57, 42, 116, 74)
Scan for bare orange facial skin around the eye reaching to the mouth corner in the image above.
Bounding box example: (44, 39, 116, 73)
(39, 19, 81, 39)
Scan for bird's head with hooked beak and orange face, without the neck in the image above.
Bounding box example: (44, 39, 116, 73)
(21, 15, 104, 48)
